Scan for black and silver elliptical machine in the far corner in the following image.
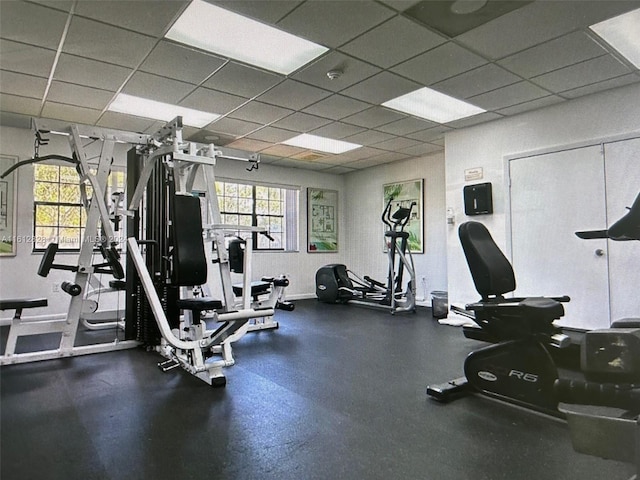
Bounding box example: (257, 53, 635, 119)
(316, 197, 416, 314)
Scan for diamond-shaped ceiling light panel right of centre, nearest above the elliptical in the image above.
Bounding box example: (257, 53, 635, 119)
(382, 87, 486, 123)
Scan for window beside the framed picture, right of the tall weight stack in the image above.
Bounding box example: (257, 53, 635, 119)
(216, 181, 298, 251)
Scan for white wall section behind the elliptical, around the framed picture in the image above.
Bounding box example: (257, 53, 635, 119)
(344, 153, 447, 300)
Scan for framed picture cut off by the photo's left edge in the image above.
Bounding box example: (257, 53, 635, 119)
(0, 154, 18, 257)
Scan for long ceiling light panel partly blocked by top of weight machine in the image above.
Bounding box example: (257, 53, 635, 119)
(108, 93, 220, 128)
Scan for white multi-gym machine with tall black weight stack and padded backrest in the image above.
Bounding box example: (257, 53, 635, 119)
(125, 117, 292, 387)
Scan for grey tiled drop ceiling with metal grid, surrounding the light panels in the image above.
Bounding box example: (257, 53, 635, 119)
(0, 0, 640, 174)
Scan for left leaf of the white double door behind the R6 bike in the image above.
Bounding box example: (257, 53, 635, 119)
(509, 145, 609, 329)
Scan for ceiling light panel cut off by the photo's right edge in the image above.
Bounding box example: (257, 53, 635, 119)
(589, 8, 640, 68)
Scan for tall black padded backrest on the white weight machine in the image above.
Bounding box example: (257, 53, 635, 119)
(171, 195, 207, 286)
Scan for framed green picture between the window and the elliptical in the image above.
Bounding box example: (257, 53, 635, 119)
(307, 188, 338, 253)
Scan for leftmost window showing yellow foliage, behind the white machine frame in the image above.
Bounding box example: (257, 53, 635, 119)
(33, 164, 125, 251)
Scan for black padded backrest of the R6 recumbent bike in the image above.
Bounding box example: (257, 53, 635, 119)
(458, 222, 516, 298)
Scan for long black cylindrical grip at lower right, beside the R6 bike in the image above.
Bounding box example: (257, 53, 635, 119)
(554, 379, 640, 410)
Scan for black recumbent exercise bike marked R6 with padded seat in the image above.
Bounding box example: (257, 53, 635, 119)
(427, 222, 570, 416)
